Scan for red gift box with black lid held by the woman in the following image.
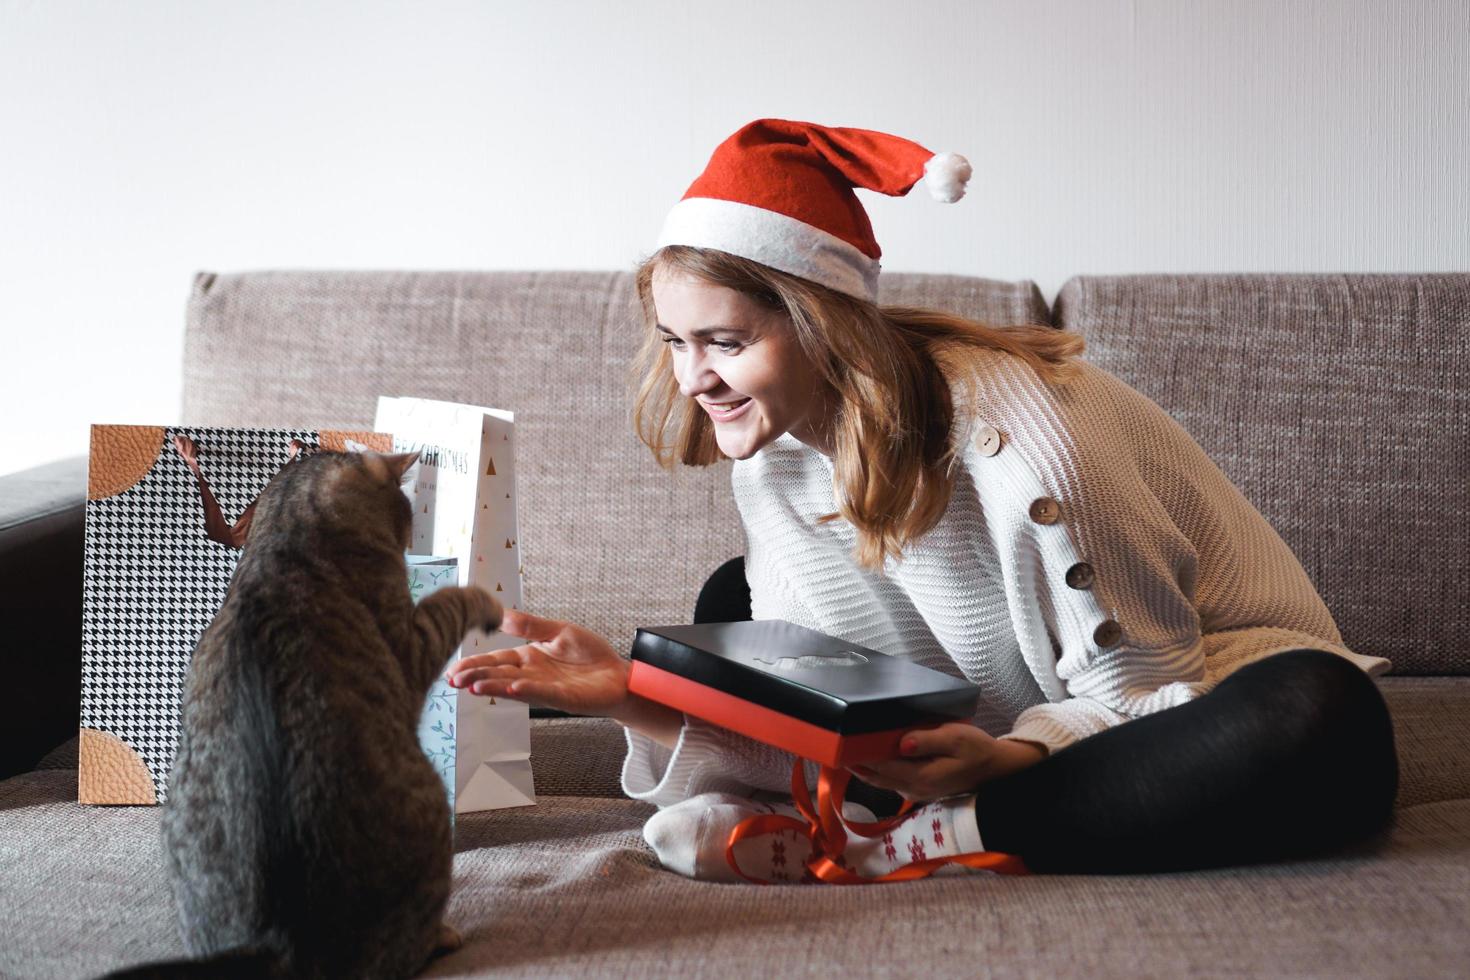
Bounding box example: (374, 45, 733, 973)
(628, 620, 980, 767)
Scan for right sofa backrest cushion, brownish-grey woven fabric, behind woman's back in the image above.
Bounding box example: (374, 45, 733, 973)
(1054, 273, 1470, 673)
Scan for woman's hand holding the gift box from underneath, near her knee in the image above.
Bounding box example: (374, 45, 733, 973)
(850, 721, 1047, 801)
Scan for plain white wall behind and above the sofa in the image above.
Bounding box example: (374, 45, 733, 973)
(0, 0, 1470, 472)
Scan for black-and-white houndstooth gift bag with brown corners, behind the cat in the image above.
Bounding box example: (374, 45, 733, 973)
(76, 425, 392, 804)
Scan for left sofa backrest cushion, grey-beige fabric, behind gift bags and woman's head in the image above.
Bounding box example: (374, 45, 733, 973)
(184, 272, 1047, 649)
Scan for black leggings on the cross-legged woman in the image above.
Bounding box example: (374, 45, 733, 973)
(694, 557, 1398, 874)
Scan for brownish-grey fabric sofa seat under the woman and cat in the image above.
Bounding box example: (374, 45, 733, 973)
(0, 677, 1470, 979)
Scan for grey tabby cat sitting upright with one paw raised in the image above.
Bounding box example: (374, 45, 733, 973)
(106, 453, 503, 977)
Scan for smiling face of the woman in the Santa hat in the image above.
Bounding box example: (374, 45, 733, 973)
(653, 269, 832, 460)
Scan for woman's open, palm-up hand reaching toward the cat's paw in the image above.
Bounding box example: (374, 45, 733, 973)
(444, 610, 628, 716)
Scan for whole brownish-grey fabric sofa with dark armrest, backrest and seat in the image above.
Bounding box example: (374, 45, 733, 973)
(0, 272, 1470, 977)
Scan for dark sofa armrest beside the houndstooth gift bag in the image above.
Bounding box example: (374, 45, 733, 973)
(0, 455, 87, 779)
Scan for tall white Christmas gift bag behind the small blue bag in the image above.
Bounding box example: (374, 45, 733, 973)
(375, 398, 535, 814)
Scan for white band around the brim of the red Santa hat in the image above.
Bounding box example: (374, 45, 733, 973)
(659, 197, 879, 303)
